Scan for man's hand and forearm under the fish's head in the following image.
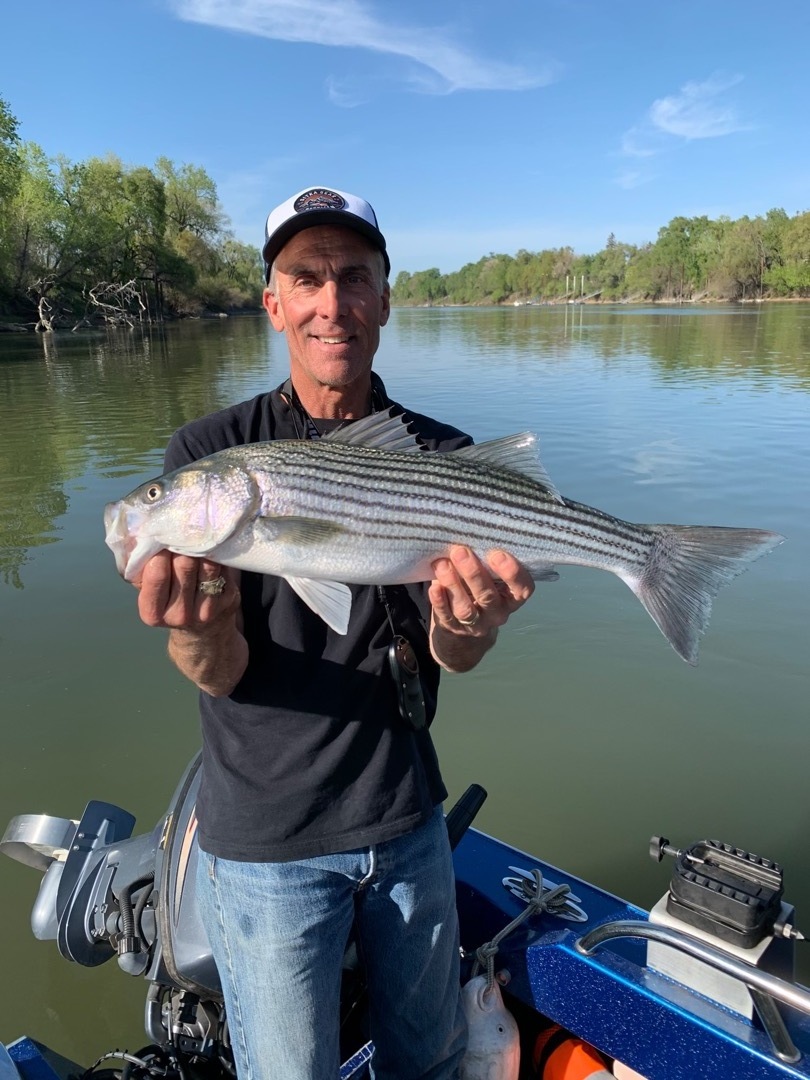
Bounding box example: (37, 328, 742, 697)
(136, 551, 247, 698)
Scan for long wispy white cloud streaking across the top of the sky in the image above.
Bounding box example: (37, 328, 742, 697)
(174, 0, 557, 96)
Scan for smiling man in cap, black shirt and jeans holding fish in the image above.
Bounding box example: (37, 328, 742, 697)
(138, 188, 534, 1080)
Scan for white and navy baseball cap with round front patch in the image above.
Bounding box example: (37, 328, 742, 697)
(261, 188, 391, 281)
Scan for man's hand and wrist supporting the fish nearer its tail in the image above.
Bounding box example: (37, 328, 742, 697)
(428, 546, 535, 672)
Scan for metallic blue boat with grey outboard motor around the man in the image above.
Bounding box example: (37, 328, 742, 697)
(0, 756, 810, 1080)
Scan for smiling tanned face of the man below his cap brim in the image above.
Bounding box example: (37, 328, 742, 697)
(264, 225, 391, 399)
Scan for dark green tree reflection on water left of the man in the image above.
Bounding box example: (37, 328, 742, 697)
(0, 318, 269, 589)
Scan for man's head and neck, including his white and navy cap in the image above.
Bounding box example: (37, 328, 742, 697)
(262, 188, 390, 417)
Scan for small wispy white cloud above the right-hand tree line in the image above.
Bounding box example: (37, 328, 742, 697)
(617, 75, 750, 166)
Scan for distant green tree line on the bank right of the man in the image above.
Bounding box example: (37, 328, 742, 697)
(392, 210, 810, 306)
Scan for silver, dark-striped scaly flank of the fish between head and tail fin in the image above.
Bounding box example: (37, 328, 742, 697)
(231, 441, 653, 569)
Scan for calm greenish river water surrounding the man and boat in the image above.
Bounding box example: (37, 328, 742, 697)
(0, 303, 810, 1062)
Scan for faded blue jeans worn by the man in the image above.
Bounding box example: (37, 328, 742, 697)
(198, 808, 467, 1080)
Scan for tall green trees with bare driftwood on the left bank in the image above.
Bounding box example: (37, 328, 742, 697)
(0, 98, 264, 330)
